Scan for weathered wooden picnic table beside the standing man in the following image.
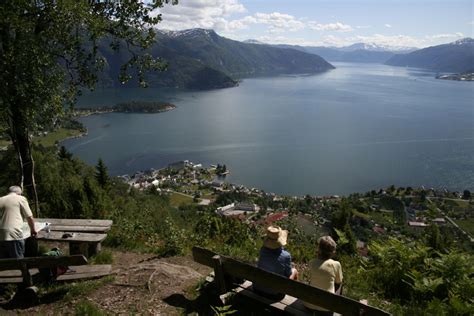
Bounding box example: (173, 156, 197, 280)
(35, 218, 113, 257)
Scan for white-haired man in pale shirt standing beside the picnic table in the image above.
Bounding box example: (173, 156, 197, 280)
(0, 185, 37, 259)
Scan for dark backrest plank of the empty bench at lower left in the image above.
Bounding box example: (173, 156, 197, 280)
(0, 255, 87, 271)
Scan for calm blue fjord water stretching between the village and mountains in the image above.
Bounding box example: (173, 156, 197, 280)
(64, 63, 474, 195)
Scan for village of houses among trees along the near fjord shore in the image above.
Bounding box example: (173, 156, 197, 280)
(121, 160, 474, 254)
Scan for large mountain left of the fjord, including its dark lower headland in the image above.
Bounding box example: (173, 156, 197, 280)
(97, 29, 334, 90)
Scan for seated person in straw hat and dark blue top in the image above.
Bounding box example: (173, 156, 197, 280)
(253, 226, 298, 300)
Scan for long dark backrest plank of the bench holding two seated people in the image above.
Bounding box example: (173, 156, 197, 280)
(193, 247, 390, 315)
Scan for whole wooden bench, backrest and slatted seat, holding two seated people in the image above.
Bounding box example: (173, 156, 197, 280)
(193, 247, 390, 316)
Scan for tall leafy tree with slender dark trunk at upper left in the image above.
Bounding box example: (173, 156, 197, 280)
(0, 0, 176, 210)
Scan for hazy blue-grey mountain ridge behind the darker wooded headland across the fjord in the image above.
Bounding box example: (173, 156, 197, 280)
(157, 29, 334, 78)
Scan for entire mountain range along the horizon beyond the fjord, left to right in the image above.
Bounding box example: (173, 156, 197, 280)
(100, 29, 474, 90)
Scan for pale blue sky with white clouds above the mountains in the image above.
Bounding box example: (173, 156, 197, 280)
(157, 0, 474, 48)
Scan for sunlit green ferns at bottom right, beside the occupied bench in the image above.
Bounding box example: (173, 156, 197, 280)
(363, 238, 474, 315)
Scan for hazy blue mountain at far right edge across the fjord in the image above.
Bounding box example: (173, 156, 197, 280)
(386, 38, 474, 73)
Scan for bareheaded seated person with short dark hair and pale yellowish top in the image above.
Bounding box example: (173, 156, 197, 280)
(304, 236, 342, 316)
